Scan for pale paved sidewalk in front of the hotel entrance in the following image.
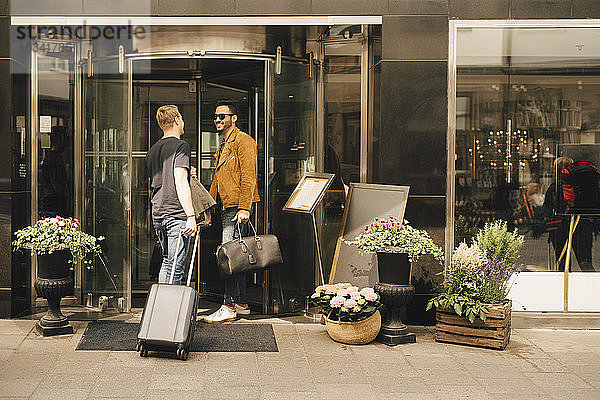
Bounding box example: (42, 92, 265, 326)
(0, 319, 600, 400)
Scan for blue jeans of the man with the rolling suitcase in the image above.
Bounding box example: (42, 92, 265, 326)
(154, 218, 190, 285)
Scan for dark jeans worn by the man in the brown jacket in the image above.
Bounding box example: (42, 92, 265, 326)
(221, 207, 254, 307)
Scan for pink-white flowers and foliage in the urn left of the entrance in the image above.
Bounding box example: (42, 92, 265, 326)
(13, 216, 104, 269)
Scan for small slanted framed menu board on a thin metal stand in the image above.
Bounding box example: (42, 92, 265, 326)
(282, 172, 335, 214)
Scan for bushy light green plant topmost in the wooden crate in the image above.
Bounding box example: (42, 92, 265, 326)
(475, 220, 525, 265)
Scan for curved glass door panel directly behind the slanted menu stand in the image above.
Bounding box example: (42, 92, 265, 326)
(268, 61, 317, 313)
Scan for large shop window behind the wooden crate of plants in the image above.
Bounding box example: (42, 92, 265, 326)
(454, 27, 600, 309)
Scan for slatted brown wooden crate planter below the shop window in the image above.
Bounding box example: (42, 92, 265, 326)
(435, 301, 512, 350)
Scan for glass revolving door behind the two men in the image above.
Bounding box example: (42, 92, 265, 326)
(79, 51, 319, 313)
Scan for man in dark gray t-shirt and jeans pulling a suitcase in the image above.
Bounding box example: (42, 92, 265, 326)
(146, 105, 196, 285)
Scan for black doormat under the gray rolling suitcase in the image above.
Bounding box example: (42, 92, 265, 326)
(76, 320, 279, 352)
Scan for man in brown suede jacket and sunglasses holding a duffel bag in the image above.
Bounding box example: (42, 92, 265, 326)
(204, 100, 259, 323)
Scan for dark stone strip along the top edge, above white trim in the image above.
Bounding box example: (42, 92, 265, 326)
(5, 0, 600, 19)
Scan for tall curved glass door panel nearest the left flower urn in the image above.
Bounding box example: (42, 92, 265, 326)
(82, 58, 131, 307)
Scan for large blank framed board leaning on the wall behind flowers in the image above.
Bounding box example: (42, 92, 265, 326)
(329, 183, 409, 287)
